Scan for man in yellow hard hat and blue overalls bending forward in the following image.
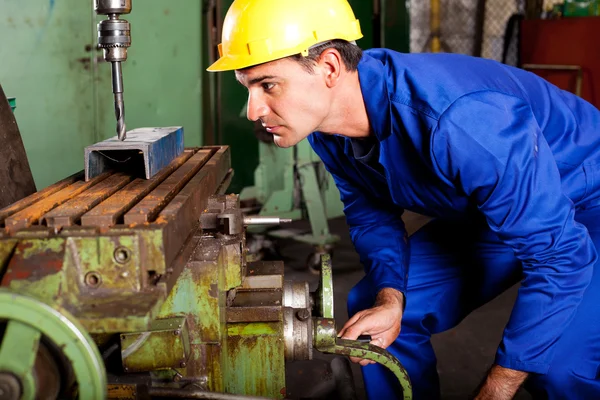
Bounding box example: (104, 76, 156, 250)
(209, 0, 600, 399)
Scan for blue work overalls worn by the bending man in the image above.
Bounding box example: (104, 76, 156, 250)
(309, 49, 600, 400)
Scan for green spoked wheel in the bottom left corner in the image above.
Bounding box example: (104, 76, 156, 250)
(0, 288, 106, 400)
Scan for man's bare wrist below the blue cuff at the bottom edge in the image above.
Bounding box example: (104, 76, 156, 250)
(475, 365, 528, 400)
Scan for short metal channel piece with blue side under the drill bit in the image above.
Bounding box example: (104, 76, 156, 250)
(84, 126, 184, 181)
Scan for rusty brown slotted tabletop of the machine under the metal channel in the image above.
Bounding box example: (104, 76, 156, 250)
(0, 147, 231, 234)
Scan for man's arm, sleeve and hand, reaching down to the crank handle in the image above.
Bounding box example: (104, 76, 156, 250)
(309, 134, 408, 356)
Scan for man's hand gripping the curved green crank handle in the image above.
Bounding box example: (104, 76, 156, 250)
(338, 288, 404, 366)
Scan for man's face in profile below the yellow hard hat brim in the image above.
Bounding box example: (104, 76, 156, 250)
(235, 58, 330, 147)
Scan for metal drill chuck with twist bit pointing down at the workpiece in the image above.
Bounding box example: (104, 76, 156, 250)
(94, 0, 131, 140)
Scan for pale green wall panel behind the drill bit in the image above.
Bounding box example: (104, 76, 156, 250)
(0, 0, 203, 190)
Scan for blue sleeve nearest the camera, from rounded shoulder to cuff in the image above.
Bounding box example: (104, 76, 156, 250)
(432, 92, 596, 374)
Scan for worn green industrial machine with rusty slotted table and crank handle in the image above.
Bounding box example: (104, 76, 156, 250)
(0, 129, 411, 399)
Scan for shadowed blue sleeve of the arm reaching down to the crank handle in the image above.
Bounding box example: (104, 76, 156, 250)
(308, 133, 409, 296)
